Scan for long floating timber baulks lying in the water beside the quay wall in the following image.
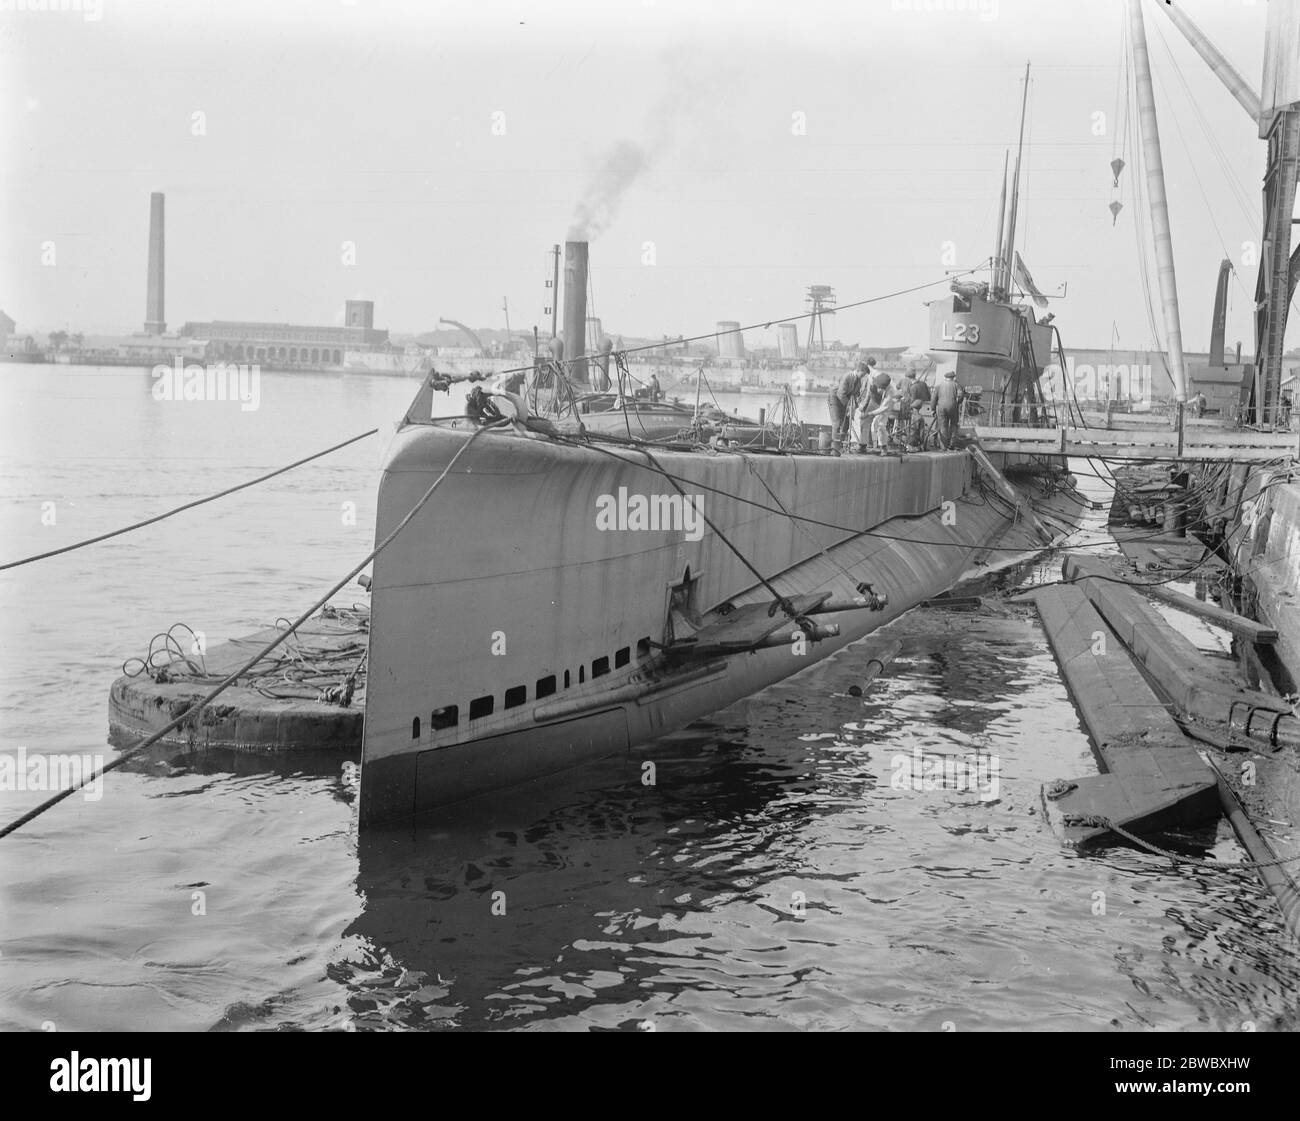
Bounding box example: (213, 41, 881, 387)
(1018, 544, 1300, 938)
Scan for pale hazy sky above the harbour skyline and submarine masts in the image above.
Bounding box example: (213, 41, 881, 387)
(0, 0, 1300, 354)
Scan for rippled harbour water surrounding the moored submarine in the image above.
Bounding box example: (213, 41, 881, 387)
(0, 365, 1300, 1031)
